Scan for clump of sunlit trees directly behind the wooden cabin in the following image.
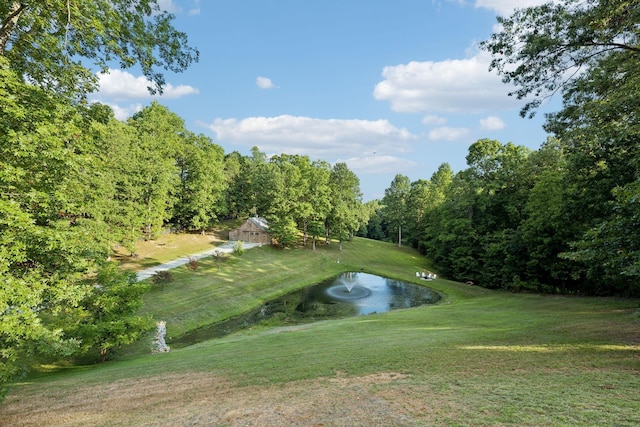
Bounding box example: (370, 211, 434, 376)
(224, 147, 368, 248)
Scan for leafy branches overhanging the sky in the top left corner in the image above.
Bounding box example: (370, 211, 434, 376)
(0, 0, 198, 98)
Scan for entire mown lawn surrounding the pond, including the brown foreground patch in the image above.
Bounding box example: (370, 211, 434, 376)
(0, 239, 640, 426)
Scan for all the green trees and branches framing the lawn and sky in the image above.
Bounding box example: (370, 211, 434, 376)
(0, 0, 640, 402)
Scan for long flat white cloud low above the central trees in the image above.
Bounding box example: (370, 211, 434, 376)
(206, 115, 417, 161)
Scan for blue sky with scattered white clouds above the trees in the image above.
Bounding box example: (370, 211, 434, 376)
(93, 0, 560, 201)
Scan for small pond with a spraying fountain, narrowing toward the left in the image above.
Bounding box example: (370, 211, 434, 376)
(169, 272, 441, 347)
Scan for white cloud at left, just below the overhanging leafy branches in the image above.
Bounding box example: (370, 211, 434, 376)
(96, 69, 198, 101)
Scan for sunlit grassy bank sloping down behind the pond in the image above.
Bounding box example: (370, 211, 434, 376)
(134, 239, 436, 336)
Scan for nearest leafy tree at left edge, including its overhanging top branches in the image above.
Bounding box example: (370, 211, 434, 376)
(0, 0, 198, 387)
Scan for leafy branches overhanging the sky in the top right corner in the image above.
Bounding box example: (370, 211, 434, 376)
(481, 0, 640, 116)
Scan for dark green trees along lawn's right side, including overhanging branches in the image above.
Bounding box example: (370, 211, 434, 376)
(365, 0, 640, 296)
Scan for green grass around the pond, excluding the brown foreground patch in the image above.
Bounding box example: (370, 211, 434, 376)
(0, 239, 640, 425)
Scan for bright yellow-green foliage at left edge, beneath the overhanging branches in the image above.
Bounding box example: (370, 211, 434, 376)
(0, 57, 102, 394)
